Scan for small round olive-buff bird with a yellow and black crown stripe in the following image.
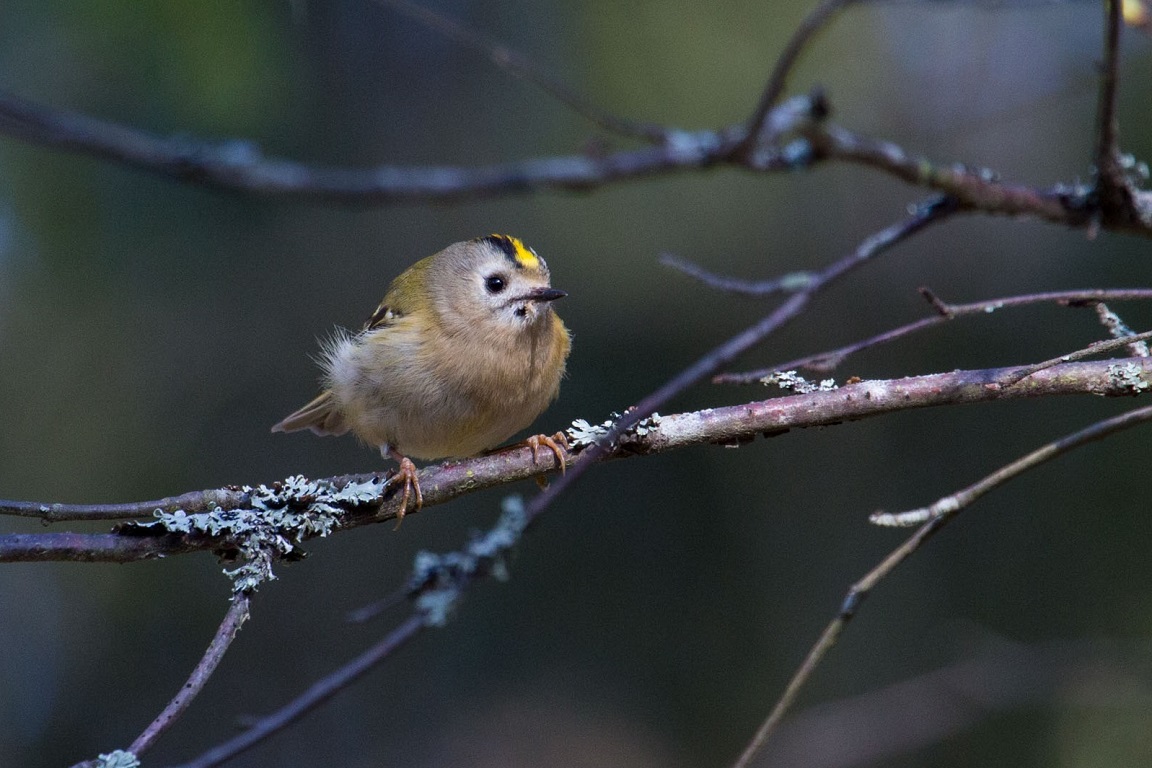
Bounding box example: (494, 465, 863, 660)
(272, 235, 571, 518)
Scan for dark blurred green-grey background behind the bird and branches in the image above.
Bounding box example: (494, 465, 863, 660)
(0, 0, 1152, 768)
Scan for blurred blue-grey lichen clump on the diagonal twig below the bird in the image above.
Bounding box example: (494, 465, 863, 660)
(408, 496, 528, 626)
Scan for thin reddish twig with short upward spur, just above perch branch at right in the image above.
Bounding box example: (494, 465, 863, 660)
(712, 288, 1152, 385)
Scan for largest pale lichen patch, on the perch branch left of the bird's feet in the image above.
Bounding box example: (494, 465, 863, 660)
(143, 476, 385, 592)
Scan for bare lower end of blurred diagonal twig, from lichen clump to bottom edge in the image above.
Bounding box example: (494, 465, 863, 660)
(168, 615, 426, 768)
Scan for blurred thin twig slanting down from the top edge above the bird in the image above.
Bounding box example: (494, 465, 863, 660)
(376, 0, 670, 144)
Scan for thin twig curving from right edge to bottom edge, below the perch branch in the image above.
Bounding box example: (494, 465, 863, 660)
(733, 405, 1152, 768)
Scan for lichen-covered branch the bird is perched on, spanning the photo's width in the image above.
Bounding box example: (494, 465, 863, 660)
(0, 358, 1152, 568)
